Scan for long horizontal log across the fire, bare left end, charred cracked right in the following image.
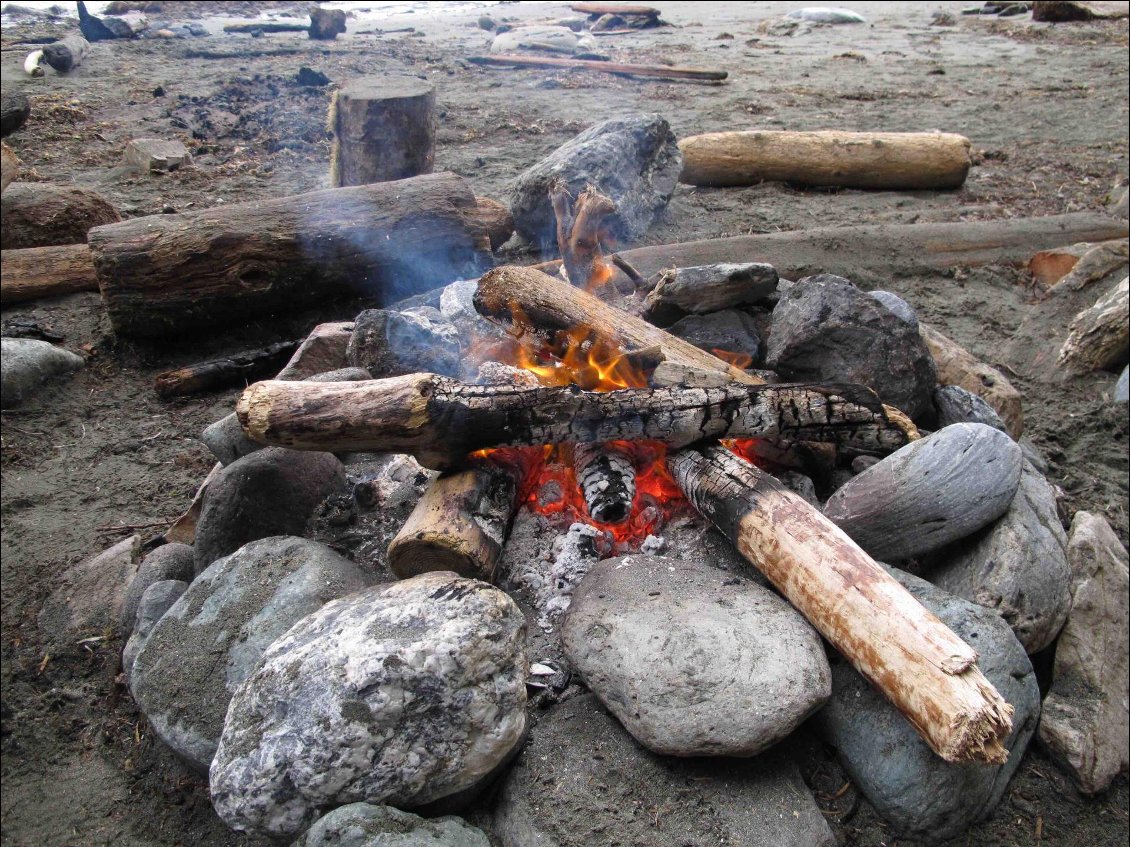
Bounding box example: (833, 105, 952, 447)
(236, 374, 910, 470)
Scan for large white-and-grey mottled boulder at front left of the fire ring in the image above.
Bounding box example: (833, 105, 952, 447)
(210, 573, 528, 837)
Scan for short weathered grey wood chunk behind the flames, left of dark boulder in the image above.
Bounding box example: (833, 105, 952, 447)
(643, 262, 780, 326)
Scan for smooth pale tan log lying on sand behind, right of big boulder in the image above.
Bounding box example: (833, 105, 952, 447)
(679, 130, 971, 191)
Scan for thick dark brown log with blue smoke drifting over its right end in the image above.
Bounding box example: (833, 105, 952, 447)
(88, 174, 489, 338)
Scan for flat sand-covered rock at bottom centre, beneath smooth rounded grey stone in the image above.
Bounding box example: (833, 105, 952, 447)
(493, 695, 836, 847)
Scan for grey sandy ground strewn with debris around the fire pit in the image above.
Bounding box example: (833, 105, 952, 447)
(0, 2, 1130, 847)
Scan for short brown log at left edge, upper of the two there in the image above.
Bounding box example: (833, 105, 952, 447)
(0, 182, 122, 250)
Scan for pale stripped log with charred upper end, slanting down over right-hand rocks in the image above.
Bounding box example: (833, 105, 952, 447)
(668, 445, 1012, 763)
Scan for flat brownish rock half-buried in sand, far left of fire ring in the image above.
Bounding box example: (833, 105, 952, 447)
(38, 535, 141, 654)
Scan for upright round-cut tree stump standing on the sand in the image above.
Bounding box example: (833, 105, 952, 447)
(330, 77, 435, 186)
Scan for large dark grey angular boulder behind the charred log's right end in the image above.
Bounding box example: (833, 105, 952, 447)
(766, 273, 938, 419)
